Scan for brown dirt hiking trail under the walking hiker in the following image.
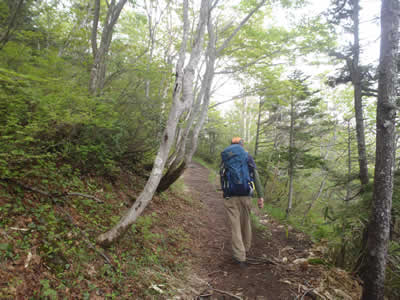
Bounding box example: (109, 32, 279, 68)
(184, 163, 360, 300)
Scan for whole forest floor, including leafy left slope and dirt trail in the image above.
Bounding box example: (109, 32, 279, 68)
(0, 163, 361, 300)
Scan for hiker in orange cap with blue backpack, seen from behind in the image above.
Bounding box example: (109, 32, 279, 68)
(220, 137, 264, 267)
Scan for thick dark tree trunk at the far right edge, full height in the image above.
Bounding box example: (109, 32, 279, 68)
(362, 0, 400, 300)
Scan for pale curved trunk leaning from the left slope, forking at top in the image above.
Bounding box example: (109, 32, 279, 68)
(97, 0, 209, 245)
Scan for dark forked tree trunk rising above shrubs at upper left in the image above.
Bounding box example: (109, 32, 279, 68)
(89, 0, 127, 95)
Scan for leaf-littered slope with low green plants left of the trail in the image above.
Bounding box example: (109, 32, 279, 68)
(0, 174, 196, 299)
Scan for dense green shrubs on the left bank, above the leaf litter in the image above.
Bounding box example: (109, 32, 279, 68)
(0, 44, 159, 178)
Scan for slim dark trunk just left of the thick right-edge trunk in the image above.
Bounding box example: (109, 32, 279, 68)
(348, 0, 369, 186)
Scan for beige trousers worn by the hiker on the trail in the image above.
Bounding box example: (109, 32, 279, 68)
(224, 196, 251, 261)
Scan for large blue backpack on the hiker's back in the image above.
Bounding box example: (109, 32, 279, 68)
(220, 144, 253, 198)
